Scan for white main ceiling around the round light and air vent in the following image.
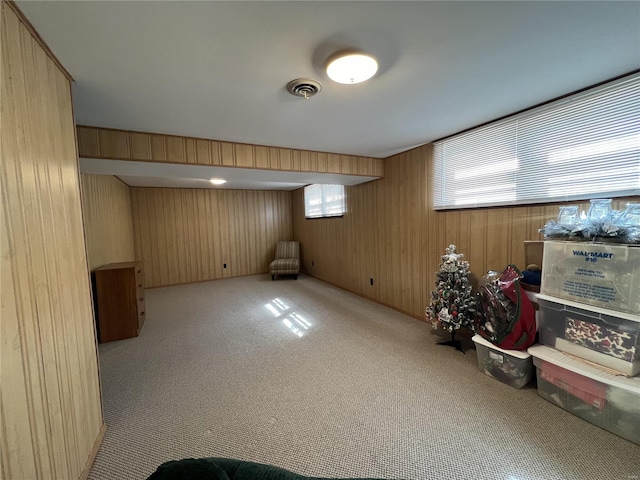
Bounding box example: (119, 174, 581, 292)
(17, 1, 640, 188)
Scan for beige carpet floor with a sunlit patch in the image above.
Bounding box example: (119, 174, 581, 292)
(89, 275, 640, 480)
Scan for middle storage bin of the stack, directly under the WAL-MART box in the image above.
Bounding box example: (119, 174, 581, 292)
(538, 294, 640, 376)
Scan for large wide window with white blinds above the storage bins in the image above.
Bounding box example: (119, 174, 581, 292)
(433, 74, 640, 210)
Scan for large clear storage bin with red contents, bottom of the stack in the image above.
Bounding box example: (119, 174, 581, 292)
(528, 345, 640, 444)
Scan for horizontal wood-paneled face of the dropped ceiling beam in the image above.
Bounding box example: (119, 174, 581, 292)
(78, 126, 384, 177)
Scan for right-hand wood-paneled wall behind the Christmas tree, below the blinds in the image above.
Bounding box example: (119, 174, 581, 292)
(292, 145, 640, 318)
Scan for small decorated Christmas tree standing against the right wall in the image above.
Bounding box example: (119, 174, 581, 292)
(425, 245, 479, 352)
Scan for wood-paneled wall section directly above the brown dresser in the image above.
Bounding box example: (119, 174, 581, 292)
(82, 175, 136, 271)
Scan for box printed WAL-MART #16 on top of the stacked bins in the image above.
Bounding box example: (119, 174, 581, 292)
(540, 240, 640, 314)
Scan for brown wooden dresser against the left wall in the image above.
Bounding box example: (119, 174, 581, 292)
(94, 262, 144, 343)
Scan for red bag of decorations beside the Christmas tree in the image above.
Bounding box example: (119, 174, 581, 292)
(477, 265, 537, 350)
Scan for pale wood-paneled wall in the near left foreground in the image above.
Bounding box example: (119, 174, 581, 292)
(0, 1, 104, 480)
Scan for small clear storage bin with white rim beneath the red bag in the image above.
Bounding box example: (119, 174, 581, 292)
(472, 335, 534, 388)
